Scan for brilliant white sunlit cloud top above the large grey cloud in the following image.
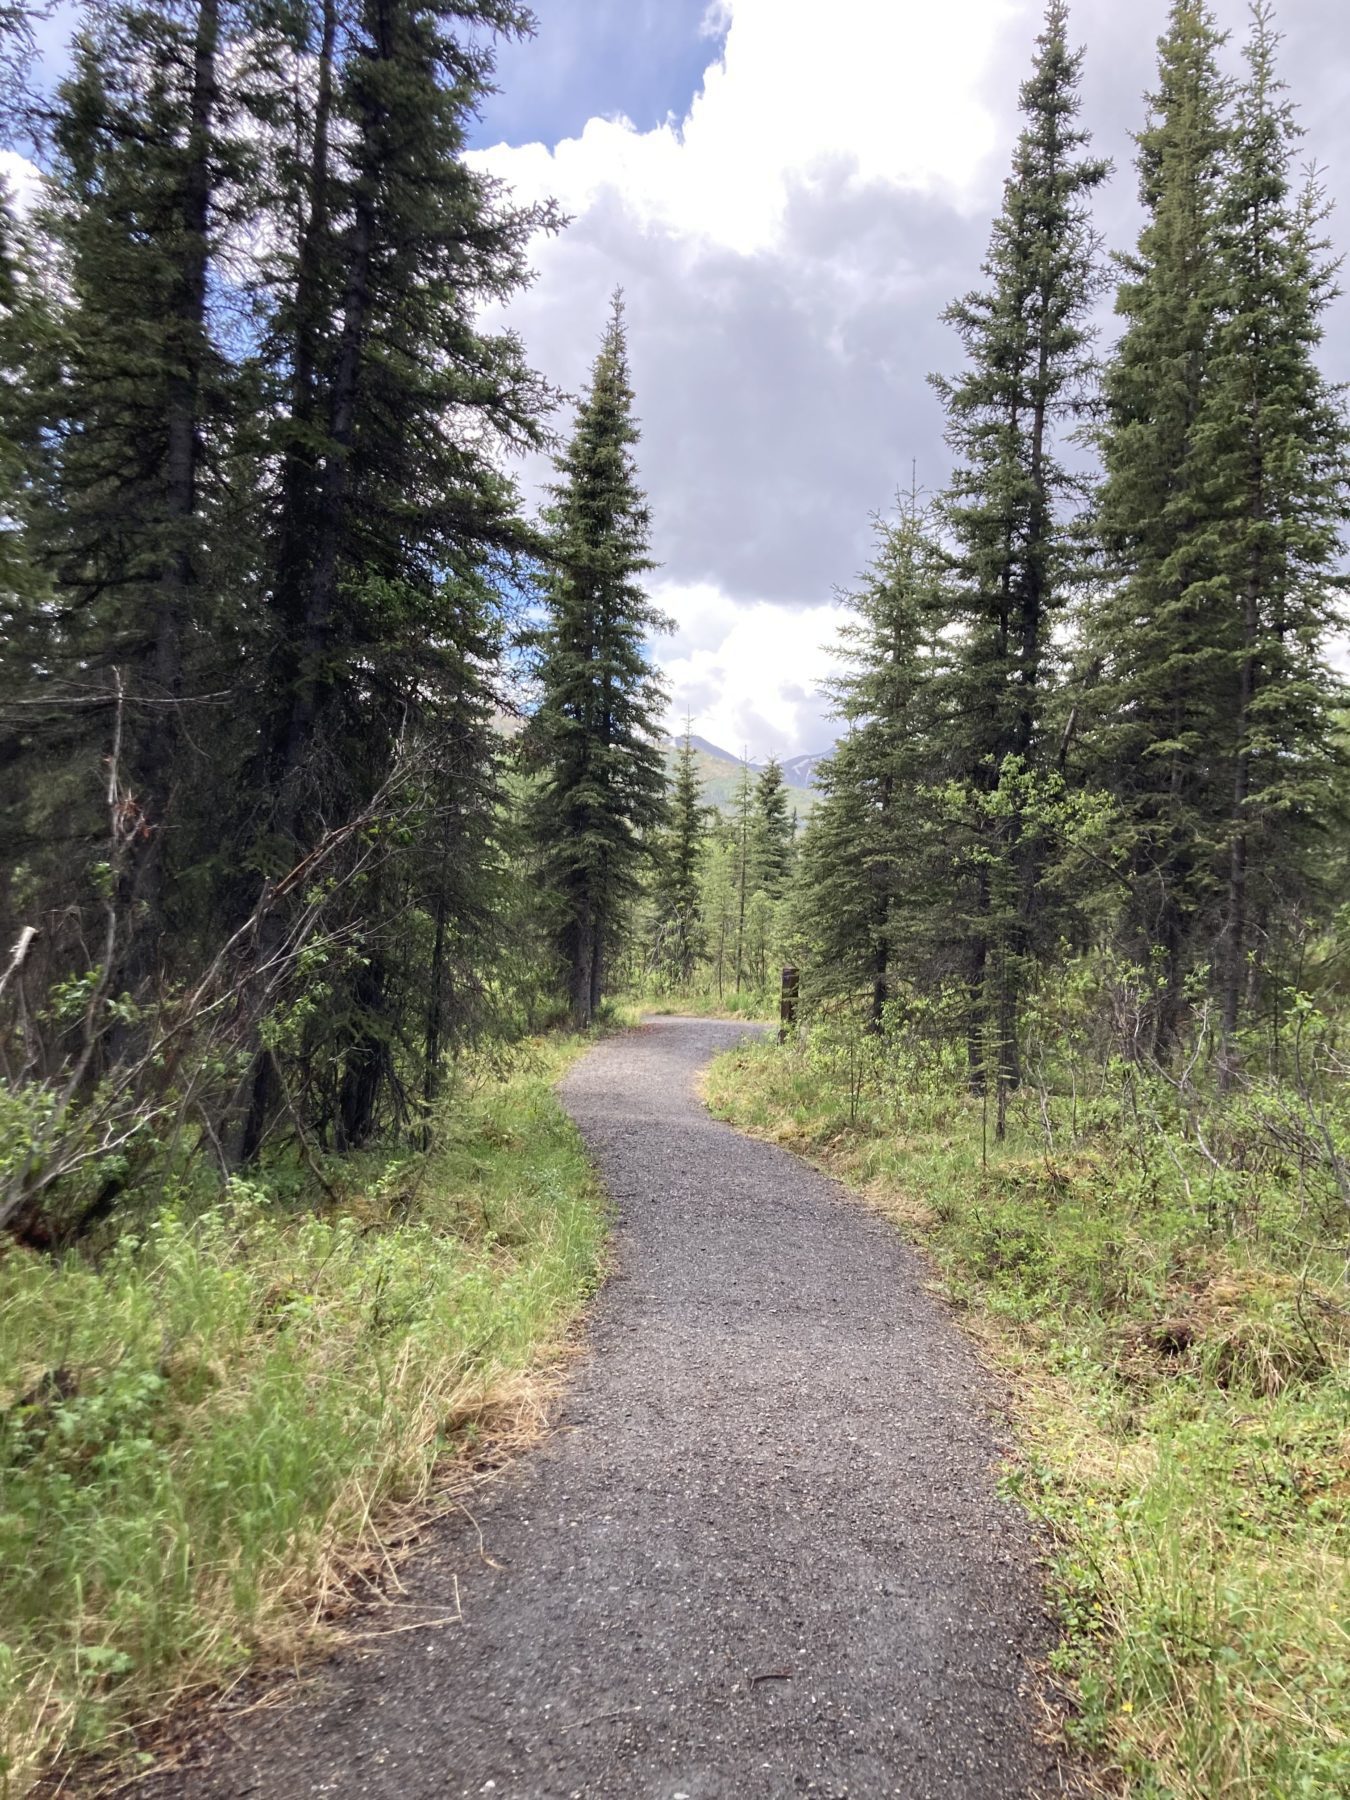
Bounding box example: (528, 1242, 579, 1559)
(481, 0, 1021, 254)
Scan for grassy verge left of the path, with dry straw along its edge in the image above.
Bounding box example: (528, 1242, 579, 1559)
(0, 1040, 607, 1800)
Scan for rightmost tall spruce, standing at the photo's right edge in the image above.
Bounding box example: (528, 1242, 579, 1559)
(1197, 4, 1350, 1042)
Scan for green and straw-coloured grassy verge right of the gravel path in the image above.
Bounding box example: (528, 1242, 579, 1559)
(707, 1042, 1350, 1800)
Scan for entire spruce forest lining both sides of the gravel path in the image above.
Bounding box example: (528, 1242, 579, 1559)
(0, 0, 1350, 1793)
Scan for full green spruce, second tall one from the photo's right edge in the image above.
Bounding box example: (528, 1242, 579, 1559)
(1080, 0, 1235, 1048)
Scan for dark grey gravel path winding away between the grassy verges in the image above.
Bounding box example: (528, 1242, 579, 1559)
(155, 1019, 1058, 1800)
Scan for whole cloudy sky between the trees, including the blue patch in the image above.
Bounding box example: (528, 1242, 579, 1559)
(475, 0, 1350, 756)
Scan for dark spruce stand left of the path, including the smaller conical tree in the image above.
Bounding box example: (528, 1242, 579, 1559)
(0, 0, 662, 1240)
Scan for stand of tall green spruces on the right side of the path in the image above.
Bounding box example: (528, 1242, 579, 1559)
(659, 4, 1350, 1096)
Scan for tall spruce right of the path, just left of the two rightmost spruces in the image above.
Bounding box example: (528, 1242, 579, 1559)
(934, 0, 1107, 1085)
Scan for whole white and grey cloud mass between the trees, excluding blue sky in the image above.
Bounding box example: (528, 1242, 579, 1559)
(475, 0, 1035, 754)
